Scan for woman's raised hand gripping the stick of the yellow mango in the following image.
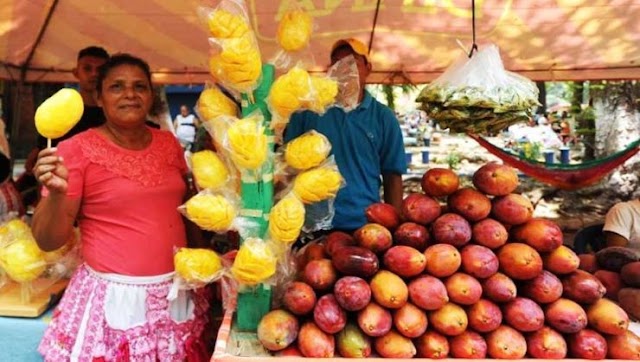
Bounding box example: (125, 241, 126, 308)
(33, 147, 69, 195)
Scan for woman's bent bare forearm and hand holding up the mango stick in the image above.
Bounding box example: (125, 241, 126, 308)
(31, 148, 80, 251)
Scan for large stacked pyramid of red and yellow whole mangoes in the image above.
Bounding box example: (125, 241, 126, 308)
(257, 163, 640, 359)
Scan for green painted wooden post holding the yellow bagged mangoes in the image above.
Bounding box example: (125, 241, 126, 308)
(236, 64, 275, 332)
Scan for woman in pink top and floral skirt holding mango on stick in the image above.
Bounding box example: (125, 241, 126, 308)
(32, 54, 208, 361)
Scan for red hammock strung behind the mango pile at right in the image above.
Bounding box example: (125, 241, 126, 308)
(467, 134, 640, 190)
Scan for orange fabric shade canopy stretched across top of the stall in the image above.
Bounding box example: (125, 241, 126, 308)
(0, 0, 640, 84)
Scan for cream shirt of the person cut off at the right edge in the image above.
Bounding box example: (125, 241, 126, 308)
(603, 199, 640, 250)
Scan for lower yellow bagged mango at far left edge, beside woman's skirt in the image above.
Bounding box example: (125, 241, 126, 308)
(0, 239, 47, 283)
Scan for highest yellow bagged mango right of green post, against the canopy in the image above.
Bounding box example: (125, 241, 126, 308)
(276, 10, 313, 52)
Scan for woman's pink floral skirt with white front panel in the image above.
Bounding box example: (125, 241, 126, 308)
(38, 265, 209, 362)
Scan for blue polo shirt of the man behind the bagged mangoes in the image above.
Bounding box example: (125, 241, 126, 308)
(284, 91, 407, 230)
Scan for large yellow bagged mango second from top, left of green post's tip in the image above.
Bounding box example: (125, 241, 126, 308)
(209, 35, 262, 92)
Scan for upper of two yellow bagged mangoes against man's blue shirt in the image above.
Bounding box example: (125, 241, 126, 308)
(284, 131, 331, 170)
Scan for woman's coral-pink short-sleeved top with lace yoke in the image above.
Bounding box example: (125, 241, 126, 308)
(43, 128, 187, 276)
